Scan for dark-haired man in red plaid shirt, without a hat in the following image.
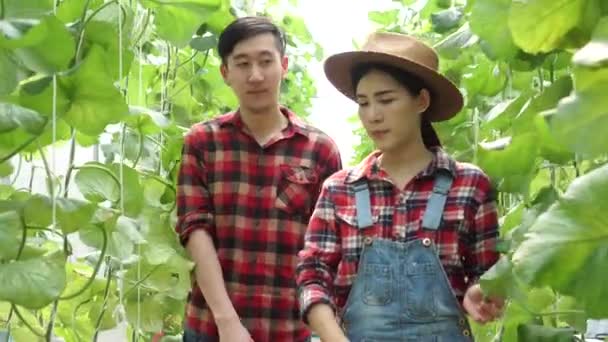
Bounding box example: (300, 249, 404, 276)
(176, 17, 341, 342)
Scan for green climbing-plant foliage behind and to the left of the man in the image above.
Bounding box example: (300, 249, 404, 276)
(0, 0, 322, 342)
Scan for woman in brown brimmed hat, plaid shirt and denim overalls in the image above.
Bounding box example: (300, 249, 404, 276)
(297, 33, 503, 342)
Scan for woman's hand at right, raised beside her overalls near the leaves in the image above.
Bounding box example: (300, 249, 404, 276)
(462, 284, 505, 324)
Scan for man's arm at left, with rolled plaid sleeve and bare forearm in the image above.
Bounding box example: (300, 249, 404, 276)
(175, 133, 249, 341)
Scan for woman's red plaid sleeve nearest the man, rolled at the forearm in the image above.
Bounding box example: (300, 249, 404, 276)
(296, 182, 341, 322)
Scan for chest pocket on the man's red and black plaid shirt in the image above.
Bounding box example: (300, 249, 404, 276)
(275, 164, 319, 215)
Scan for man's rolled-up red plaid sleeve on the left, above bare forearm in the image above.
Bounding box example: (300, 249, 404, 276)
(175, 132, 215, 246)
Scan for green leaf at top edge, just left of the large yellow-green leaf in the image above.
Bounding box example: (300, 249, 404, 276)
(470, 0, 518, 60)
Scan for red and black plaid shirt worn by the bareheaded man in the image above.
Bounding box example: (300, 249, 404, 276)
(176, 109, 341, 342)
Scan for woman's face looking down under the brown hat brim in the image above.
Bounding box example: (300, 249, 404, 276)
(356, 69, 430, 152)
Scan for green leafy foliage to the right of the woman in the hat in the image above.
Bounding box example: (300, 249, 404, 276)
(353, 0, 608, 342)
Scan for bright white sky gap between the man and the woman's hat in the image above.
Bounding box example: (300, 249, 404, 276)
(297, 0, 391, 165)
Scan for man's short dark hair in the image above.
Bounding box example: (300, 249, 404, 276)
(217, 16, 286, 63)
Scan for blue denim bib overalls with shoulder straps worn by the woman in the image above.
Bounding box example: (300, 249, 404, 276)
(342, 172, 472, 342)
